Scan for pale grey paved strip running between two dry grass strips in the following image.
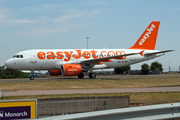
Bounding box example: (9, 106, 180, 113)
(1, 87, 180, 96)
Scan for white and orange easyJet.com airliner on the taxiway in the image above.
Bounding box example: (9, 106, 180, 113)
(5, 21, 173, 80)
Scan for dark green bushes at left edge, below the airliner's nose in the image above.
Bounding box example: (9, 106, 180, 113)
(0, 66, 29, 79)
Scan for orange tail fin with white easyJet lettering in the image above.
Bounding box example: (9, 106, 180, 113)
(129, 21, 160, 50)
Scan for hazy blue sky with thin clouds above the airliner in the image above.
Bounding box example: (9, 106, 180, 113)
(0, 0, 180, 71)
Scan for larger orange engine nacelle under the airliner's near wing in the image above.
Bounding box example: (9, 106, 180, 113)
(61, 64, 88, 76)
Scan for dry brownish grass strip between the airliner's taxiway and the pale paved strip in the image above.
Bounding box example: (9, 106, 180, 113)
(0, 77, 180, 90)
